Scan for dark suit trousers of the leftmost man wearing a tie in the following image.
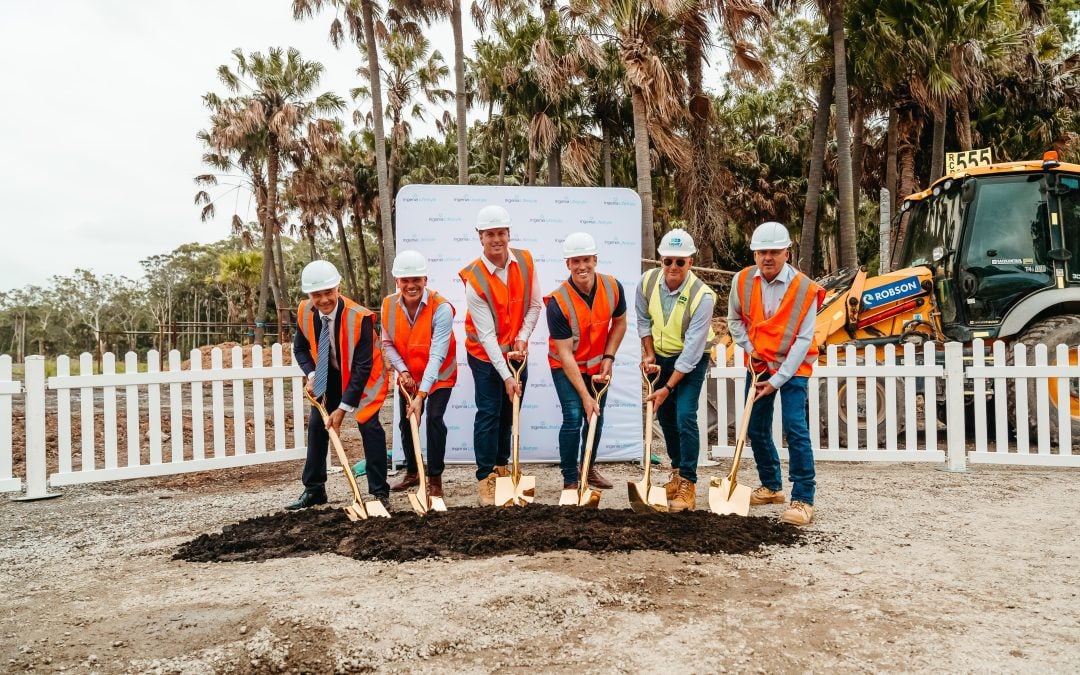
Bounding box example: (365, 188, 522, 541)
(301, 368, 390, 497)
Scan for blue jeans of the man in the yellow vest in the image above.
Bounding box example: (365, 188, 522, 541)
(649, 352, 708, 483)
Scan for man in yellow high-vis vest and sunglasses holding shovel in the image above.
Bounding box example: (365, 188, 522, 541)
(636, 228, 716, 512)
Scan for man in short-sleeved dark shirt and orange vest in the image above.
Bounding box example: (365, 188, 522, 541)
(544, 232, 626, 489)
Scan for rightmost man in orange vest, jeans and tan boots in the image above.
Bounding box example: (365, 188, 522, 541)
(728, 222, 825, 525)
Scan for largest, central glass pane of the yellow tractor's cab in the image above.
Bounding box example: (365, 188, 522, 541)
(959, 174, 1053, 325)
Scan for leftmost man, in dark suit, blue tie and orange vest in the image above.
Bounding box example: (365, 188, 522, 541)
(285, 260, 390, 511)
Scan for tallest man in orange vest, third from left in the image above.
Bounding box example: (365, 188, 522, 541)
(459, 204, 543, 505)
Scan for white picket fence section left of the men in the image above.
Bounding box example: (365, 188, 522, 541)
(10, 345, 307, 497)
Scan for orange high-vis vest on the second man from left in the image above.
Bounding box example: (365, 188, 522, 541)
(382, 289, 458, 393)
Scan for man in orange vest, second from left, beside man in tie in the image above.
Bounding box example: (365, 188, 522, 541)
(381, 251, 458, 497)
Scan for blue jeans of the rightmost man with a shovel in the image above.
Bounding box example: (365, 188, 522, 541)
(746, 376, 815, 505)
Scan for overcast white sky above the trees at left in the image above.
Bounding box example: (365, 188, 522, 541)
(0, 0, 475, 289)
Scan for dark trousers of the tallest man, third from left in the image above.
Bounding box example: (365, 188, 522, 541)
(469, 354, 529, 481)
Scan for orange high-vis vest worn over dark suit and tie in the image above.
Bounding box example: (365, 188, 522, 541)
(296, 296, 390, 423)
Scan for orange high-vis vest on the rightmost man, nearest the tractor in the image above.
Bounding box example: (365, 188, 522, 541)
(731, 266, 825, 377)
